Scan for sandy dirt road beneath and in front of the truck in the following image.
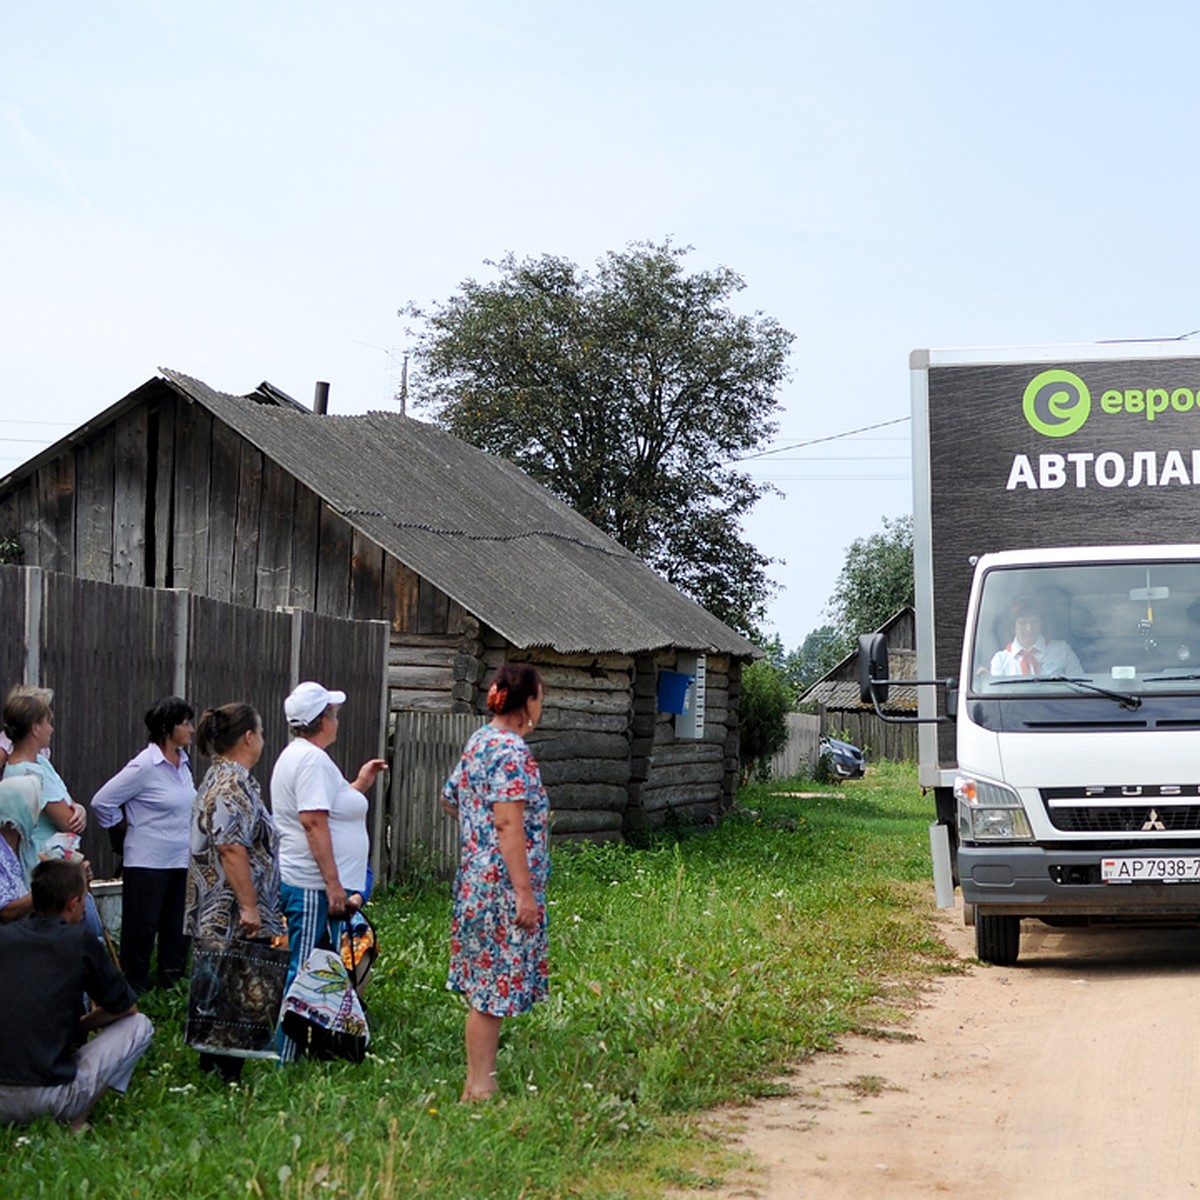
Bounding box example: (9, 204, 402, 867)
(709, 911, 1200, 1200)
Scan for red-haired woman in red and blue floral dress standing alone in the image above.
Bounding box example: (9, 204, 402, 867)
(442, 662, 550, 1100)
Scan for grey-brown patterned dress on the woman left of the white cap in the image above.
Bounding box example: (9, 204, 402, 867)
(184, 755, 283, 944)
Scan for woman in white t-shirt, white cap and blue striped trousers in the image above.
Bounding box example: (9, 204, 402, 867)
(271, 682, 388, 1060)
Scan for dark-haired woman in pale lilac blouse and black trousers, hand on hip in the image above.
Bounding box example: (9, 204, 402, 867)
(91, 696, 196, 992)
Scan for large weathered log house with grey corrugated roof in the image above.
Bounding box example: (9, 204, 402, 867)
(0, 371, 756, 839)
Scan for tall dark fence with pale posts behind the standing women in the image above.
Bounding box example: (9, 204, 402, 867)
(0, 566, 388, 878)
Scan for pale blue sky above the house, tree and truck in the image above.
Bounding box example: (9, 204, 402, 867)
(0, 0, 1200, 647)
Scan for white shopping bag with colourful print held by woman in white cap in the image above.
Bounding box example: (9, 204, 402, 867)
(282, 944, 371, 1062)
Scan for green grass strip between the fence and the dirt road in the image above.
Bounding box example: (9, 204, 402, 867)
(0, 766, 953, 1200)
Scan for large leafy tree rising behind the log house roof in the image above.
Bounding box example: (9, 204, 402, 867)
(401, 241, 792, 634)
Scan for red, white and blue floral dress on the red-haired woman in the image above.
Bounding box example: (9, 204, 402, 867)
(442, 725, 550, 1016)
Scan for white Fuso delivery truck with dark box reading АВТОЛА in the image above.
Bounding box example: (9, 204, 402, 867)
(860, 341, 1200, 965)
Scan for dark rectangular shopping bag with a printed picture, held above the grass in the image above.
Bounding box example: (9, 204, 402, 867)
(185, 938, 288, 1058)
